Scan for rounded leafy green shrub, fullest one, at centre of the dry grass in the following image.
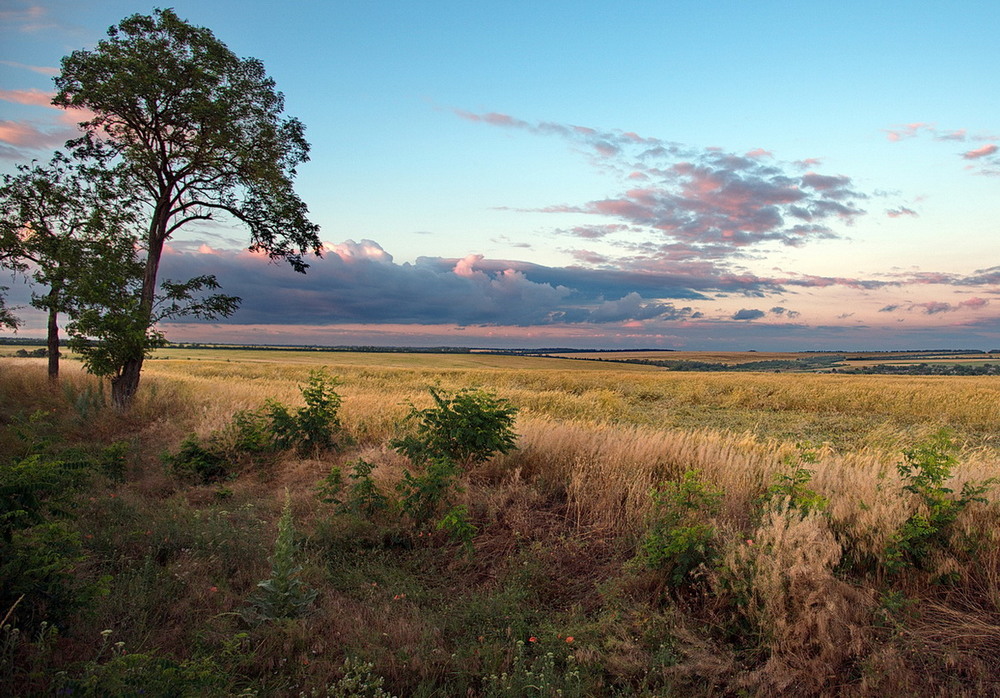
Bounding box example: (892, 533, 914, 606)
(393, 388, 517, 467)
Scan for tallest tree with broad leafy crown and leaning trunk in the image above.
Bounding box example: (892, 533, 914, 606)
(53, 9, 320, 406)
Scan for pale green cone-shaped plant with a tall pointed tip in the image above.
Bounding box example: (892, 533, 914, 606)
(250, 491, 318, 621)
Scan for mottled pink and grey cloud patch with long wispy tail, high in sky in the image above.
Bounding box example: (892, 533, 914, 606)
(453, 110, 868, 258)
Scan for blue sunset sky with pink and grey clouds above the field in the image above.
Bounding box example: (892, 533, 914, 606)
(0, 0, 1000, 351)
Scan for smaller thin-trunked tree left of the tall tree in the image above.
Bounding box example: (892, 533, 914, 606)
(0, 152, 141, 380)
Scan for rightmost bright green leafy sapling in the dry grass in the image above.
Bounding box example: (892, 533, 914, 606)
(883, 430, 995, 572)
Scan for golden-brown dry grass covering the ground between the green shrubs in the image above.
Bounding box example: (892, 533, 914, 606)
(0, 351, 1000, 696)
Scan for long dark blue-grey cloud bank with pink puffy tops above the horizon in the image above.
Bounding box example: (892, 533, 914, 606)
(163, 240, 695, 327)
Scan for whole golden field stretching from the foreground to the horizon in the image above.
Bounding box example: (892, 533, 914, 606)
(0, 349, 1000, 696)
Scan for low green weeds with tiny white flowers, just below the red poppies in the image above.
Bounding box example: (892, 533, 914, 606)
(483, 640, 586, 698)
